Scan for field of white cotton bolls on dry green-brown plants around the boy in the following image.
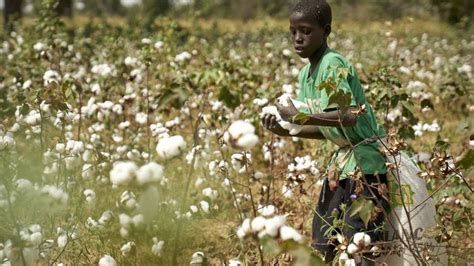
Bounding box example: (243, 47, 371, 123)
(0, 9, 474, 265)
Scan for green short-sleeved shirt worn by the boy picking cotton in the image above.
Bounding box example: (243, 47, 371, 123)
(298, 48, 387, 179)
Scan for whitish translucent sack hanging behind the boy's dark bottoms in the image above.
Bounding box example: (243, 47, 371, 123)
(378, 152, 448, 266)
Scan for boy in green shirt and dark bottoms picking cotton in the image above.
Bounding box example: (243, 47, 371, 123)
(262, 0, 388, 261)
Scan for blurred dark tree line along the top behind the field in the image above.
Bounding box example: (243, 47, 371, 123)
(4, 0, 474, 31)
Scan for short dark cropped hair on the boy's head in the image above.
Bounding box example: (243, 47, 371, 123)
(292, 0, 332, 27)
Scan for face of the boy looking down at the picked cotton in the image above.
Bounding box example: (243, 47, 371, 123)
(290, 12, 330, 58)
